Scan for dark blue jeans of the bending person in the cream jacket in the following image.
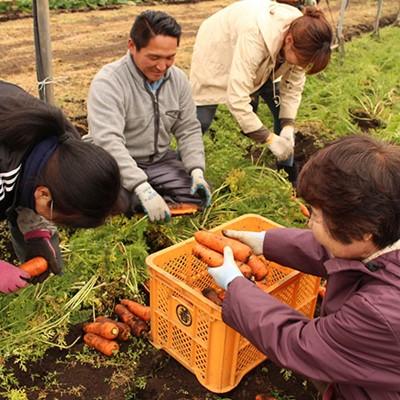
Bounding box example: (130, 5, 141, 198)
(196, 79, 294, 168)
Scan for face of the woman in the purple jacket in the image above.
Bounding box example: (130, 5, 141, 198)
(308, 207, 379, 260)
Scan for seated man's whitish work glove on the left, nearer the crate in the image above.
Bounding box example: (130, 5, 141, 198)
(135, 182, 171, 222)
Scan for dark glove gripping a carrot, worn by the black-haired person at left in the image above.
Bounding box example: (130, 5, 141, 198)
(24, 229, 63, 283)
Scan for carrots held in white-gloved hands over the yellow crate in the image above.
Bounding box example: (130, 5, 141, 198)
(192, 231, 268, 281)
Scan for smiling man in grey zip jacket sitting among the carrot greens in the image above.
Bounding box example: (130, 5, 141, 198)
(87, 10, 211, 221)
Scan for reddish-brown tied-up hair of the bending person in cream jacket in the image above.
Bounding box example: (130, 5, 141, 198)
(288, 7, 333, 75)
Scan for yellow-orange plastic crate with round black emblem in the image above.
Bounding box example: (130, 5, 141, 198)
(146, 214, 320, 393)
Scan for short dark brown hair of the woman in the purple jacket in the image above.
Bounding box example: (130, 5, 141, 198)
(297, 135, 400, 248)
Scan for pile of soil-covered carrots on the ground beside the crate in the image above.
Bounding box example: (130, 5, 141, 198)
(83, 299, 150, 356)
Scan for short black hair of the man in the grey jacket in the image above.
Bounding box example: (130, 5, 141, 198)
(130, 10, 182, 50)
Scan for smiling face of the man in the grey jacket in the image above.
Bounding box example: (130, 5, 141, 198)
(128, 35, 178, 83)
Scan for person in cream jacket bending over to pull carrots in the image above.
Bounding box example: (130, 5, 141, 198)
(190, 0, 333, 181)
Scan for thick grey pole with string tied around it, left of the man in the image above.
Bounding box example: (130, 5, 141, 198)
(32, 0, 54, 104)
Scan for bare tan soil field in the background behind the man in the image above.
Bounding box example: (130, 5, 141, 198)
(0, 0, 399, 125)
